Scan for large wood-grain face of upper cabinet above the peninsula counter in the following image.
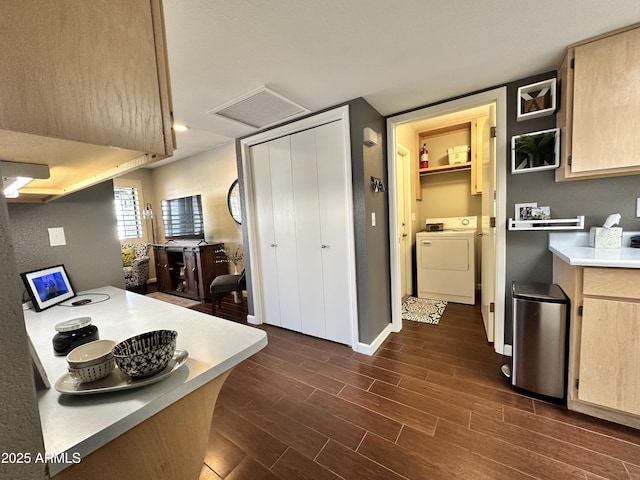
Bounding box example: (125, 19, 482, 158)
(0, 0, 172, 154)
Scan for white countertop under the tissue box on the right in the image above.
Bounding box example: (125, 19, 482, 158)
(549, 232, 640, 268)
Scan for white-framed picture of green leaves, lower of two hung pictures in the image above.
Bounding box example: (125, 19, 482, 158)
(511, 128, 560, 174)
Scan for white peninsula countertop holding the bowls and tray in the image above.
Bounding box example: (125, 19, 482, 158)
(24, 287, 267, 476)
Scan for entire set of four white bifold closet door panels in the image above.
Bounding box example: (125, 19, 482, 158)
(251, 121, 352, 345)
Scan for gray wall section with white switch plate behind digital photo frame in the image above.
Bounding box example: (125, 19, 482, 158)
(8, 180, 124, 290)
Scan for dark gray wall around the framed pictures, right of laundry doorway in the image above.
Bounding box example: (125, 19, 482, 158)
(503, 71, 640, 344)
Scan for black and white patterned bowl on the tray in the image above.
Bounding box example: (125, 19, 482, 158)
(112, 330, 178, 378)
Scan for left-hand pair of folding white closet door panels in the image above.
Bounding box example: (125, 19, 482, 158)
(251, 137, 301, 332)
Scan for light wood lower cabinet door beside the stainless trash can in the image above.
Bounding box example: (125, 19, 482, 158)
(578, 298, 640, 415)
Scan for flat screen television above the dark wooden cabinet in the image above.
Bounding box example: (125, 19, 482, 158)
(162, 195, 204, 240)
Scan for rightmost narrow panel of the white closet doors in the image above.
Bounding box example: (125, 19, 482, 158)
(314, 121, 355, 345)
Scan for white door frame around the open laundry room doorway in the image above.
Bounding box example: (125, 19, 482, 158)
(387, 87, 507, 355)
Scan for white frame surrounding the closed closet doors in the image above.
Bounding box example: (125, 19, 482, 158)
(240, 106, 359, 351)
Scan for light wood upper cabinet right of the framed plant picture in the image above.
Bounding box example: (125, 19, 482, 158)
(556, 25, 640, 181)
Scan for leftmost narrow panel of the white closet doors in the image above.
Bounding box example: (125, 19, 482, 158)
(251, 143, 281, 326)
